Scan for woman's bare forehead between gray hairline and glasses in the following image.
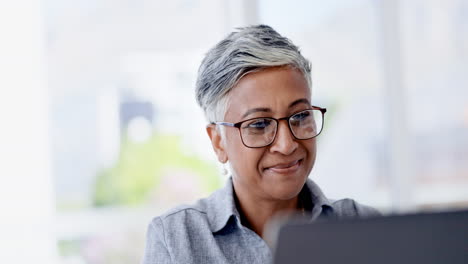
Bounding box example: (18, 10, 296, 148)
(226, 67, 311, 118)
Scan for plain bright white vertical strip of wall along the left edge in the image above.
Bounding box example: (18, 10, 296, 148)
(0, 0, 57, 263)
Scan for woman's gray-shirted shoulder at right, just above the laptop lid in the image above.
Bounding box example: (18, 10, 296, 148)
(329, 198, 382, 218)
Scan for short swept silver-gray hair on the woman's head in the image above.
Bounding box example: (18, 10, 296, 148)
(195, 25, 312, 122)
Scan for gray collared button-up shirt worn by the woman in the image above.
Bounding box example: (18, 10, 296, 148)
(142, 178, 379, 264)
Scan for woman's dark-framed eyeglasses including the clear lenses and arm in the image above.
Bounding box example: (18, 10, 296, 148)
(211, 106, 327, 148)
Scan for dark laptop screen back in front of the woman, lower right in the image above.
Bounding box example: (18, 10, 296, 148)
(273, 210, 468, 264)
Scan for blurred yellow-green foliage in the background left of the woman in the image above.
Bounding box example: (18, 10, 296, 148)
(93, 133, 221, 207)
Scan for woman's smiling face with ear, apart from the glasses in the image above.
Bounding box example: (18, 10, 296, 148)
(208, 67, 316, 200)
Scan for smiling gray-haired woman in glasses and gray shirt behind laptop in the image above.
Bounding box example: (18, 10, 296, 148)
(143, 25, 378, 264)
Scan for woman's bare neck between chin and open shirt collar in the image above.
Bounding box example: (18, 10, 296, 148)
(234, 183, 299, 238)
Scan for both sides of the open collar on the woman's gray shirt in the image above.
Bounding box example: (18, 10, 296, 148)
(206, 177, 332, 233)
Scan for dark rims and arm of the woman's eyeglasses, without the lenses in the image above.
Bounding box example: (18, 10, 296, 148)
(210, 106, 327, 148)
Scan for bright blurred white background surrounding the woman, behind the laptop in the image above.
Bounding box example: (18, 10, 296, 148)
(0, 0, 468, 264)
